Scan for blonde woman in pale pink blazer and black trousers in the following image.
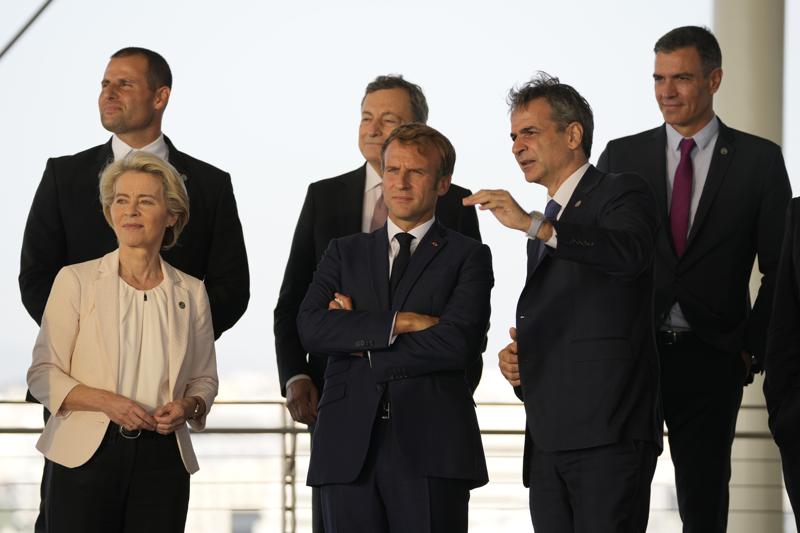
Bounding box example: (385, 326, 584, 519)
(28, 152, 218, 533)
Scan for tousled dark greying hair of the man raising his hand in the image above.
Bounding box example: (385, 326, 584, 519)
(508, 71, 594, 159)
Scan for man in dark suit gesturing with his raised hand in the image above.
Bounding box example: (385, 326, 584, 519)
(464, 73, 661, 533)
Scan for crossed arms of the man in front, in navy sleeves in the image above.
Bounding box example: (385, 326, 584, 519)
(298, 241, 494, 381)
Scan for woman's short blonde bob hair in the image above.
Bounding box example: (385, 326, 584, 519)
(100, 152, 189, 250)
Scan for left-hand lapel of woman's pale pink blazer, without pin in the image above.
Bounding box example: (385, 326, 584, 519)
(94, 250, 119, 391)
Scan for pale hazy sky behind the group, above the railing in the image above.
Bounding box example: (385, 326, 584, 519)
(0, 0, 800, 400)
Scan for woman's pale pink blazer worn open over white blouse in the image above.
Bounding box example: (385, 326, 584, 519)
(28, 250, 218, 473)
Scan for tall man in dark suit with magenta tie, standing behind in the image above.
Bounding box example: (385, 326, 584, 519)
(597, 26, 790, 533)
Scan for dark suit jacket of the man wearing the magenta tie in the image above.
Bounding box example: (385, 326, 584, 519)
(597, 121, 791, 357)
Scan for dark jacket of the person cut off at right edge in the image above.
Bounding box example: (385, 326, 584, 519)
(764, 198, 800, 446)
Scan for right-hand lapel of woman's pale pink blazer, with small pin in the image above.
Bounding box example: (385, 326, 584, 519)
(161, 259, 193, 397)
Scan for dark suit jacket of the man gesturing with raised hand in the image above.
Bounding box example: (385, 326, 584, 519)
(516, 167, 661, 482)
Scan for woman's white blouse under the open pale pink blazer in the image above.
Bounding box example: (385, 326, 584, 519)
(118, 278, 170, 414)
